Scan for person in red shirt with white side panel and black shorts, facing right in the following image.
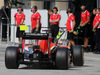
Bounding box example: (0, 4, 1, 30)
(66, 8, 76, 49)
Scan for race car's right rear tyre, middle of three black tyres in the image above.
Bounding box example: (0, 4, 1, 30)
(55, 47, 70, 69)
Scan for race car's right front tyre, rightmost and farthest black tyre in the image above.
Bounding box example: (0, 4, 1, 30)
(72, 45, 84, 66)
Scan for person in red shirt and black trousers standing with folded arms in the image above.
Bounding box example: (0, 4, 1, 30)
(49, 7, 61, 42)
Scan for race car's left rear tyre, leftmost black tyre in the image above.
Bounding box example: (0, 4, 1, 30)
(5, 47, 19, 69)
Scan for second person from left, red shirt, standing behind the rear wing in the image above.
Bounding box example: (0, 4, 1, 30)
(31, 6, 41, 33)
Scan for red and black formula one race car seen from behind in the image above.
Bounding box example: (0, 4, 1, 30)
(5, 27, 84, 69)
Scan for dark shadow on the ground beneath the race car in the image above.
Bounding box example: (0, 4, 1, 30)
(19, 63, 92, 70)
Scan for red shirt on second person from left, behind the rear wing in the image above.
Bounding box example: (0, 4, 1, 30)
(31, 12, 41, 29)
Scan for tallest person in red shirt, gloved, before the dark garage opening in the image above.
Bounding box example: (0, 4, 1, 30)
(80, 5, 90, 52)
